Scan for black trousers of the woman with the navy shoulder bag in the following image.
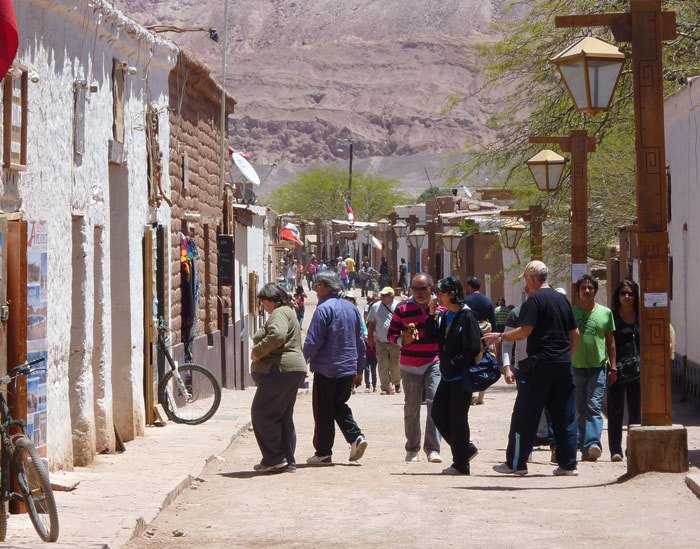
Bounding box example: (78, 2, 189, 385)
(432, 379, 472, 472)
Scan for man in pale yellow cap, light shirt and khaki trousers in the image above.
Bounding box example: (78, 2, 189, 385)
(367, 286, 401, 395)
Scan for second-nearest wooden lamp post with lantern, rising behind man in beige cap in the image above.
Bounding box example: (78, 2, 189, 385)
(527, 130, 595, 303)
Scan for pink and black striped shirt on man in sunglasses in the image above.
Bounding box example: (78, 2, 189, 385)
(387, 297, 445, 368)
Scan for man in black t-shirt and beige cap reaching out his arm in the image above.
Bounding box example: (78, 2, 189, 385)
(483, 261, 578, 476)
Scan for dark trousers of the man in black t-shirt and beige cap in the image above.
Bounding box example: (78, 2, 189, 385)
(506, 362, 578, 470)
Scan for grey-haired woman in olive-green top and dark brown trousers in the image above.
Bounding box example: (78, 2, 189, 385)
(250, 283, 306, 472)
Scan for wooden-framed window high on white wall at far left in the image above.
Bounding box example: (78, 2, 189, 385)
(3, 64, 28, 170)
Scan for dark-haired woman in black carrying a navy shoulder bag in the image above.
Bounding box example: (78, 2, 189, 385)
(425, 276, 481, 475)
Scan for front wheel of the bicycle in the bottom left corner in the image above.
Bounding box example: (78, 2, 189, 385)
(13, 436, 58, 542)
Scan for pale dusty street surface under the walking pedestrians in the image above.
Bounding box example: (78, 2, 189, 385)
(128, 288, 700, 549)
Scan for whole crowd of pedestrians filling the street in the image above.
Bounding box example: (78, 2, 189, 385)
(251, 256, 652, 476)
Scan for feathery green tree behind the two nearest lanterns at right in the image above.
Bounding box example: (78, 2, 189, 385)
(448, 0, 700, 267)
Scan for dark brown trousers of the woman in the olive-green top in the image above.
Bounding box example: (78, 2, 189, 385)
(250, 364, 306, 467)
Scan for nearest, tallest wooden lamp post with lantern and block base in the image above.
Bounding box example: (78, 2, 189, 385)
(553, 0, 688, 475)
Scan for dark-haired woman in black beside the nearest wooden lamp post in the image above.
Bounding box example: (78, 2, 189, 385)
(607, 280, 642, 461)
